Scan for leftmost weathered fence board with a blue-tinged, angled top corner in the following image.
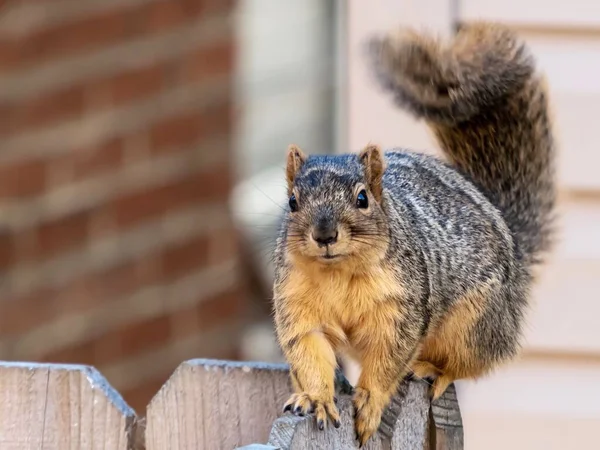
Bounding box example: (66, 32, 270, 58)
(0, 362, 137, 450)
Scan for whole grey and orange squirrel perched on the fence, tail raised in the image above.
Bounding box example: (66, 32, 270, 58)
(273, 21, 556, 446)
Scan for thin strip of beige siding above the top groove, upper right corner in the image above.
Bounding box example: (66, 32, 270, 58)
(458, 0, 600, 28)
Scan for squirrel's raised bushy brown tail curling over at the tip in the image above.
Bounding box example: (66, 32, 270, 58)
(369, 22, 556, 263)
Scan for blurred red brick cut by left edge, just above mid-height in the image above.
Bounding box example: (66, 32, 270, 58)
(0, 159, 47, 198)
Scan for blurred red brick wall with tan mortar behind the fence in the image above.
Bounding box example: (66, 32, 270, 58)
(0, 0, 246, 409)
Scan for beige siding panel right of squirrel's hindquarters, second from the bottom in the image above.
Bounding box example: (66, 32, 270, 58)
(526, 199, 600, 355)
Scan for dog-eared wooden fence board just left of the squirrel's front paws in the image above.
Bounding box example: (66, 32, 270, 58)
(146, 359, 291, 450)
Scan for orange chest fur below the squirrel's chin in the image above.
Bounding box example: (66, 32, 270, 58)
(280, 267, 403, 340)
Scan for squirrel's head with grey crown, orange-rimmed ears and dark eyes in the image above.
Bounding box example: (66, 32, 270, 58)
(286, 145, 389, 268)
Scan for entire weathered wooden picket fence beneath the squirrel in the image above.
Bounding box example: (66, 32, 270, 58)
(0, 359, 463, 450)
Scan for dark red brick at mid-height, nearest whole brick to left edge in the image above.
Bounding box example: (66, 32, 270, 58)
(37, 211, 90, 258)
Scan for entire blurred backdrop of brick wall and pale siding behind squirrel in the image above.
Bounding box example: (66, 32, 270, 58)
(0, 0, 600, 450)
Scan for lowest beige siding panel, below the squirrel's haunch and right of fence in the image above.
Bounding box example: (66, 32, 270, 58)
(457, 358, 600, 450)
